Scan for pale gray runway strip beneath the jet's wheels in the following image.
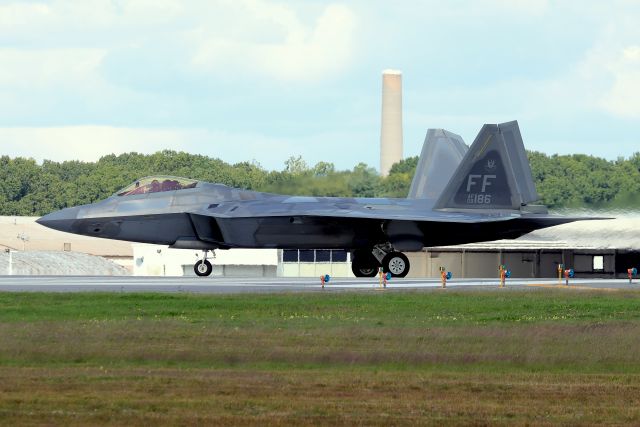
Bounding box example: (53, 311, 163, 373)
(0, 276, 640, 294)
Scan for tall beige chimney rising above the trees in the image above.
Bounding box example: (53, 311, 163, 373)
(380, 70, 402, 176)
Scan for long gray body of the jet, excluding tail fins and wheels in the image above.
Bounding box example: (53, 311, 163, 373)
(38, 176, 572, 251)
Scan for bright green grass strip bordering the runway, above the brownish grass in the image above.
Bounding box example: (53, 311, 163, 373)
(0, 290, 640, 327)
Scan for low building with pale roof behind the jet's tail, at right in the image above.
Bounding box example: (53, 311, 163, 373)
(411, 217, 640, 278)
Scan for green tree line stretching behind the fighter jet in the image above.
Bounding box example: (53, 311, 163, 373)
(0, 150, 640, 216)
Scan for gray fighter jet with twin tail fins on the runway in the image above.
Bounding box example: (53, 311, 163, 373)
(38, 121, 584, 277)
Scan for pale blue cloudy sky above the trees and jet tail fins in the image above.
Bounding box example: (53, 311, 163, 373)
(0, 0, 640, 169)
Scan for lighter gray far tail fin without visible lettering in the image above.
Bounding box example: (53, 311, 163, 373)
(407, 129, 468, 199)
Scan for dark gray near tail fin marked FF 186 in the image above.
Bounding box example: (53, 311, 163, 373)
(434, 121, 539, 210)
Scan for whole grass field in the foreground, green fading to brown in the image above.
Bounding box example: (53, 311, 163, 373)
(0, 289, 640, 425)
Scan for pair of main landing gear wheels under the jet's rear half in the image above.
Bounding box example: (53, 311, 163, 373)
(351, 243, 411, 277)
